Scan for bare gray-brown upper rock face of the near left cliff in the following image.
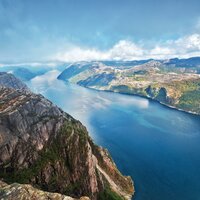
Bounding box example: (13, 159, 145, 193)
(0, 88, 66, 168)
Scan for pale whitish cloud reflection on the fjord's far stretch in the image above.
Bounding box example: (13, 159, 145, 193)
(27, 70, 149, 129)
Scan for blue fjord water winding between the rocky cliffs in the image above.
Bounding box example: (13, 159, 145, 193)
(28, 70, 200, 200)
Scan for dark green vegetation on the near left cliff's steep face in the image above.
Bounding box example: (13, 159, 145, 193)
(0, 120, 95, 195)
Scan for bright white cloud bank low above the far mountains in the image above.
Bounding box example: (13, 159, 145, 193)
(51, 33, 200, 62)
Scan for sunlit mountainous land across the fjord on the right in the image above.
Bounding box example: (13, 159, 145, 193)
(58, 57, 200, 114)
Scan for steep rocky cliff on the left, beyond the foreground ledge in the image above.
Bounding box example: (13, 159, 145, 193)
(0, 73, 134, 200)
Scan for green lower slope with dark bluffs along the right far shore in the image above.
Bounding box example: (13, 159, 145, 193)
(110, 79, 200, 113)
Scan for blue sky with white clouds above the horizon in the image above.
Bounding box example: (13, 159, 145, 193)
(0, 0, 200, 63)
